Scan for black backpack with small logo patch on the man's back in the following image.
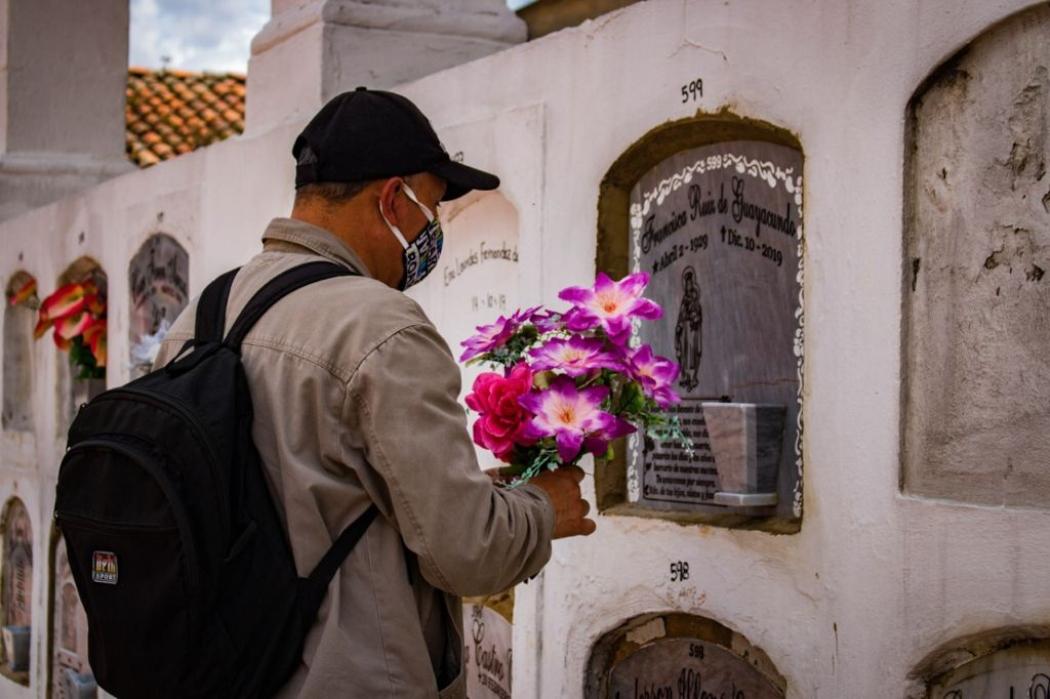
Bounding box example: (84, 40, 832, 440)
(55, 262, 376, 699)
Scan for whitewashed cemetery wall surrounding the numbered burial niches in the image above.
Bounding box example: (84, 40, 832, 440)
(0, 0, 1050, 699)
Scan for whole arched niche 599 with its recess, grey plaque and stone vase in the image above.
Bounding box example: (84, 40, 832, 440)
(595, 111, 804, 533)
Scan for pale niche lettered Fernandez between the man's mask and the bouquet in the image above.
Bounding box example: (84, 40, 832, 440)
(410, 187, 521, 468)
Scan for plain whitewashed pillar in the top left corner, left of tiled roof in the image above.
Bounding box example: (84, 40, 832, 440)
(0, 0, 132, 220)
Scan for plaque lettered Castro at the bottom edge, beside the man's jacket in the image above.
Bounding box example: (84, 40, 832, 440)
(463, 603, 513, 699)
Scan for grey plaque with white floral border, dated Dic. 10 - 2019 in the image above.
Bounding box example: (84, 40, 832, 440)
(628, 141, 802, 516)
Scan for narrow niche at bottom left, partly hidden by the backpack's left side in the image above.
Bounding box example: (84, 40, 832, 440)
(47, 529, 98, 699)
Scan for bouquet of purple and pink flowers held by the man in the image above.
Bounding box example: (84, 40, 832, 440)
(460, 273, 690, 487)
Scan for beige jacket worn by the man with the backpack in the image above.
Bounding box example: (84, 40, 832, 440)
(156, 218, 553, 699)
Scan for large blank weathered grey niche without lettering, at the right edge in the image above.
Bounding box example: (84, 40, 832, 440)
(901, 3, 1050, 508)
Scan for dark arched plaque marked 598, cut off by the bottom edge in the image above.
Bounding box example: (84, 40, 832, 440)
(609, 638, 784, 699)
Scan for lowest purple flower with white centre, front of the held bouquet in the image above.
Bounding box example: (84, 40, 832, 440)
(518, 376, 634, 464)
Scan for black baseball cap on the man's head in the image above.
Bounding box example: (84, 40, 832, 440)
(292, 87, 500, 202)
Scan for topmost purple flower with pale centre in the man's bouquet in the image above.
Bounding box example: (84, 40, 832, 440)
(558, 272, 663, 345)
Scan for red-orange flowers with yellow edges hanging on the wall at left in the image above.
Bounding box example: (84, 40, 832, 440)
(34, 280, 106, 379)
